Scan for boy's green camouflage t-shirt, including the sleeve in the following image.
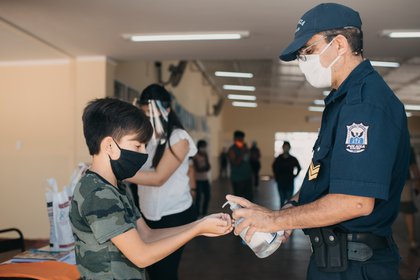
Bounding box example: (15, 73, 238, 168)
(70, 171, 146, 280)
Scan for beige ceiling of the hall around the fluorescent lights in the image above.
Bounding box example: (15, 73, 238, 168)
(0, 0, 420, 111)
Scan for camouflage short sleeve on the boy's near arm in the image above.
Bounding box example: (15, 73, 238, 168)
(81, 189, 135, 244)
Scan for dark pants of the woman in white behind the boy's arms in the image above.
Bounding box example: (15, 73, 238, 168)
(144, 203, 196, 280)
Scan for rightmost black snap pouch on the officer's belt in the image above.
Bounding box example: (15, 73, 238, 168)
(319, 228, 348, 272)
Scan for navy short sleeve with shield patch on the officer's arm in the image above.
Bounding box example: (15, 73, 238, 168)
(330, 103, 401, 200)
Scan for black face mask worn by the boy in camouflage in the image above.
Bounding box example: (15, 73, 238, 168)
(109, 140, 148, 181)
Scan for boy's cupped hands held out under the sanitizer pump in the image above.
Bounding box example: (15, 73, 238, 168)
(197, 213, 233, 237)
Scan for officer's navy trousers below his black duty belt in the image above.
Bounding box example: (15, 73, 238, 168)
(306, 238, 400, 280)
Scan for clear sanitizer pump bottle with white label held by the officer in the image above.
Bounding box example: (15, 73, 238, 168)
(222, 201, 284, 258)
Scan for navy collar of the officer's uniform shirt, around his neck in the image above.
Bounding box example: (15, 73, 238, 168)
(324, 59, 375, 105)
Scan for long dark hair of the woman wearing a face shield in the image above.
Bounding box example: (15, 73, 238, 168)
(137, 84, 184, 167)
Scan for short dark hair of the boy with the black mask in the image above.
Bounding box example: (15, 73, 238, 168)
(82, 98, 153, 155)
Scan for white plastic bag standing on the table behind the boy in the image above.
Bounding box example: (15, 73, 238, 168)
(45, 163, 89, 251)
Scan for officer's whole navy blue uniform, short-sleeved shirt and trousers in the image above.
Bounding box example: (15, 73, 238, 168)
(299, 60, 410, 279)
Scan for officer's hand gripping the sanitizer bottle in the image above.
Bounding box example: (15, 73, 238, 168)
(226, 195, 277, 242)
